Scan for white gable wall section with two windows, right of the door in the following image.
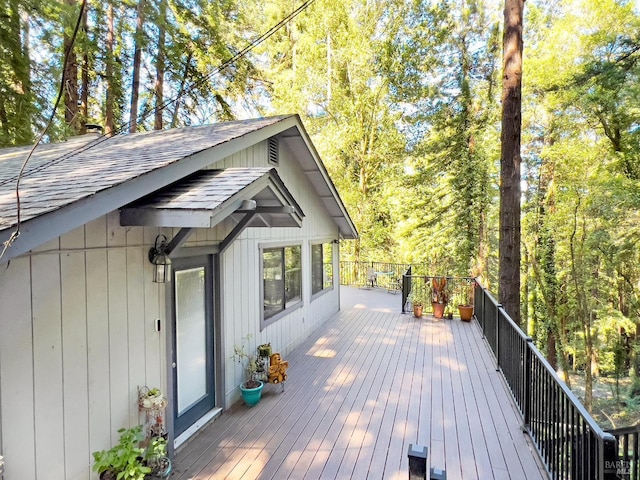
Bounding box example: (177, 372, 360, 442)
(214, 141, 339, 406)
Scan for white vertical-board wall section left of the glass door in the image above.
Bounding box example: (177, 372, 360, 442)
(0, 212, 167, 480)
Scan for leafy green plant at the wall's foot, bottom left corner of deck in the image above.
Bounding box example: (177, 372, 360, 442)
(93, 425, 151, 480)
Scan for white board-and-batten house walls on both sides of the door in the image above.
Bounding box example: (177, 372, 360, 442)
(0, 137, 339, 480)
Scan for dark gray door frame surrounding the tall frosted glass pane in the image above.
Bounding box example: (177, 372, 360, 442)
(165, 253, 224, 455)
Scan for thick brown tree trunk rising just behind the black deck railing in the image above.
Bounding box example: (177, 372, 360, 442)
(499, 0, 524, 324)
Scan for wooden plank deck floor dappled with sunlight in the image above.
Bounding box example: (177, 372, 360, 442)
(171, 288, 547, 480)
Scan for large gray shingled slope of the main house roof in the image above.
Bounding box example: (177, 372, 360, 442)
(0, 116, 288, 231)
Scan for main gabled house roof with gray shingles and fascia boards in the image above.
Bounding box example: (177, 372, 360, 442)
(0, 115, 358, 262)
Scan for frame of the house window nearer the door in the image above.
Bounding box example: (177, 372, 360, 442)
(259, 242, 304, 330)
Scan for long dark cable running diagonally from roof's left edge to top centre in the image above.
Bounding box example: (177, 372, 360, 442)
(0, 0, 315, 188)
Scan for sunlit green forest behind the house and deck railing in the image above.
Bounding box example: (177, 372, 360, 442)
(0, 0, 640, 427)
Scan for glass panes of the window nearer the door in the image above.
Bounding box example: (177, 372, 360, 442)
(262, 245, 302, 319)
